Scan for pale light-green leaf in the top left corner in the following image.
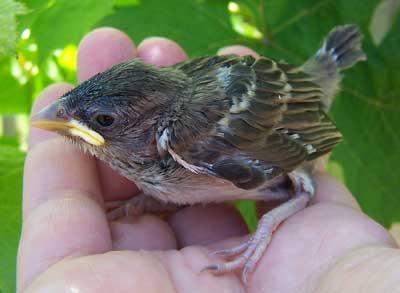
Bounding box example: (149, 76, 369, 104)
(0, 0, 27, 56)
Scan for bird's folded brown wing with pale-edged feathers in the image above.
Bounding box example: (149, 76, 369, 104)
(158, 56, 341, 189)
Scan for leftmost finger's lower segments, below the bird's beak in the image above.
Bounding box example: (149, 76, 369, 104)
(18, 117, 111, 288)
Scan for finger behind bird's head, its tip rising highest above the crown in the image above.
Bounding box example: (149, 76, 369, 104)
(78, 28, 138, 200)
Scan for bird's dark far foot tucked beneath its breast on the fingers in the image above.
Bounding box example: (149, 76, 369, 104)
(105, 193, 180, 221)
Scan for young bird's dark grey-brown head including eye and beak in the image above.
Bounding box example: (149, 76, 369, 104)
(31, 60, 188, 163)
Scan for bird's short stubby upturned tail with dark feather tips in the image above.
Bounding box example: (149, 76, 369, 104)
(302, 24, 366, 110)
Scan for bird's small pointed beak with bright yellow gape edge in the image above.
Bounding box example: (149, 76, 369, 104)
(30, 101, 105, 146)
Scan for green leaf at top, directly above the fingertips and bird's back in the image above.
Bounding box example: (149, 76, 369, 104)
(99, 0, 242, 56)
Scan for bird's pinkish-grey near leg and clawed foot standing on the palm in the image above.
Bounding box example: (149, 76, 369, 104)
(203, 170, 314, 283)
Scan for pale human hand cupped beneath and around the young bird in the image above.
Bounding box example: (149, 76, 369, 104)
(17, 28, 400, 293)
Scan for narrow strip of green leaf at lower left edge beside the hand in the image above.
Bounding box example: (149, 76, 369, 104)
(0, 145, 24, 292)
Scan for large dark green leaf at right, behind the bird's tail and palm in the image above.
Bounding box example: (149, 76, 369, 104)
(332, 23, 400, 227)
